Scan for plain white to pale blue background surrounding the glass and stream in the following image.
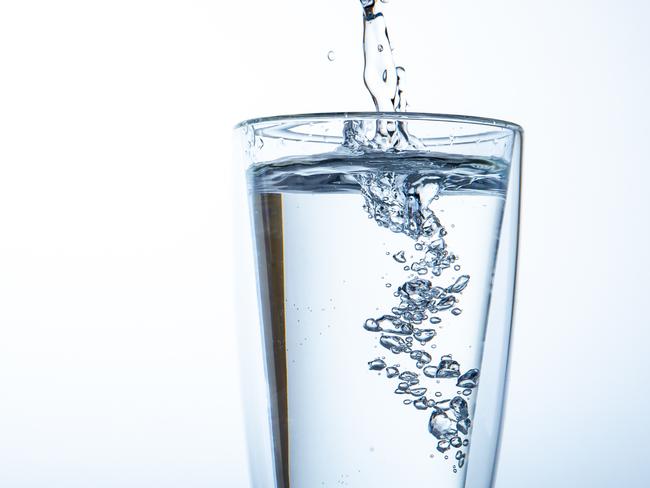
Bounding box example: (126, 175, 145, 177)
(0, 0, 650, 488)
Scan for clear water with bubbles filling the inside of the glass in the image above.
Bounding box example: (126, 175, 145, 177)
(248, 152, 507, 488)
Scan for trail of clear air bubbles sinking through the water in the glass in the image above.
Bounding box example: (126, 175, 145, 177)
(357, 172, 479, 472)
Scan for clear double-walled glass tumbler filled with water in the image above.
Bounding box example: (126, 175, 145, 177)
(234, 112, 522, 488)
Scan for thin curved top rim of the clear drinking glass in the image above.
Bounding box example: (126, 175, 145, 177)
(233, 112, 524, 134)
